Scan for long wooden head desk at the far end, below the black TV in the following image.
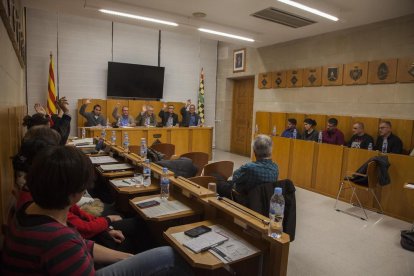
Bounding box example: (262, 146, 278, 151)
(78, 127, 213, 160)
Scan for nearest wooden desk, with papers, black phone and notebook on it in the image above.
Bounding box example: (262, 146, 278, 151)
(164, 220, 265, 275)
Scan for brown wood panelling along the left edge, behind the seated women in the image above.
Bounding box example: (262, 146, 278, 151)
(0, 106, 27, 233)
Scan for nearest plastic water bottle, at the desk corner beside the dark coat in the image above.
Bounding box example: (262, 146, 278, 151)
(268, 187, 285, 239)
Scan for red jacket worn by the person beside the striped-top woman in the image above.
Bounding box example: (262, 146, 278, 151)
(16, 191, 109, 239)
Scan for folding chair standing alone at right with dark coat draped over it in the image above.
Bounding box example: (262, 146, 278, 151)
(334, 161, 384, 220)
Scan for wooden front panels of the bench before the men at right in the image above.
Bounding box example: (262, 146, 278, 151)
(272, 137, 414, 222)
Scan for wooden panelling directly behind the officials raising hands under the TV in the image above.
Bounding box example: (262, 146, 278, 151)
(77, 99, 186, 127)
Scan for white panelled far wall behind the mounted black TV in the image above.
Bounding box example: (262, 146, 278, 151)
(27, 9, 217, 137)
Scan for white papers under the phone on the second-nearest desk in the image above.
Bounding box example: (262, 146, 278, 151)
(134, 197, 191, 218)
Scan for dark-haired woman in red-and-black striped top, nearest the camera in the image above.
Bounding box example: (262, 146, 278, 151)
(2, 146, 191, 275)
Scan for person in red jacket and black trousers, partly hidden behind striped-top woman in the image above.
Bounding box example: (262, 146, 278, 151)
(13, 126, 151, 253)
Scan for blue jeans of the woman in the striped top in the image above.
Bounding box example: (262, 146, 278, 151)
(96, 246, 193, 276)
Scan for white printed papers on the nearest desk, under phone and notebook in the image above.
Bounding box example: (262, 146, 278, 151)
(172, 225, 260, 264)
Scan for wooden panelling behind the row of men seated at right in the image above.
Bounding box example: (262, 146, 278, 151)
(256, 111, 414, 153)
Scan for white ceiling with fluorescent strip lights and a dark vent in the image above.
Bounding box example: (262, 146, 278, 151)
(22, 0, 414, 47)
